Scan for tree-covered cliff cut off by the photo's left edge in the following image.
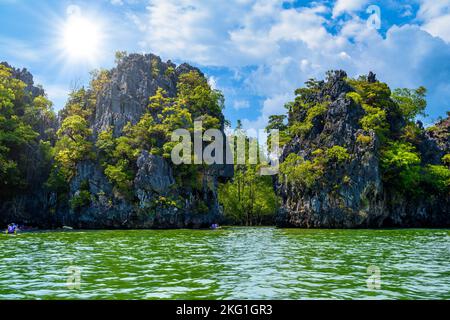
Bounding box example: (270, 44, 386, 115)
(0, 62, 58, 224)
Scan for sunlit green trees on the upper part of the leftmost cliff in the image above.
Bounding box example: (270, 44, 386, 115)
(0, 64, 55, 196)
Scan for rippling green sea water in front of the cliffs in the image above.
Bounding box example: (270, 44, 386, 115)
(0, 227, 450, 299)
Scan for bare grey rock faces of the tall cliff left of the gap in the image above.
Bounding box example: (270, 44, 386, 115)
(58, 54, 233, 228)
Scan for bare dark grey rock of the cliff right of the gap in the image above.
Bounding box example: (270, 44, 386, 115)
(275, 71, 450, 228)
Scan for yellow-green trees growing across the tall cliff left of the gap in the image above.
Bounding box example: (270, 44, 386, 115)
(48, 55, 227, 212)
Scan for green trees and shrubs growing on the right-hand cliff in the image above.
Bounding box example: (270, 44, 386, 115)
(274, 76, 450, 196)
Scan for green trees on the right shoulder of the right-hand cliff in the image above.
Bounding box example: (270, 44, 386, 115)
(347, 77, 450, 196)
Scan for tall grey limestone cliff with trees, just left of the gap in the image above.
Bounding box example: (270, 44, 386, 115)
(57, 54, 233, 228)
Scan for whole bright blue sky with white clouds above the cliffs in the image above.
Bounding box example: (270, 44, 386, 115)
(0, 0, 450, 129)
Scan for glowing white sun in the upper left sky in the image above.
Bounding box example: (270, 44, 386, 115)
(60, 6, 103, 64)
